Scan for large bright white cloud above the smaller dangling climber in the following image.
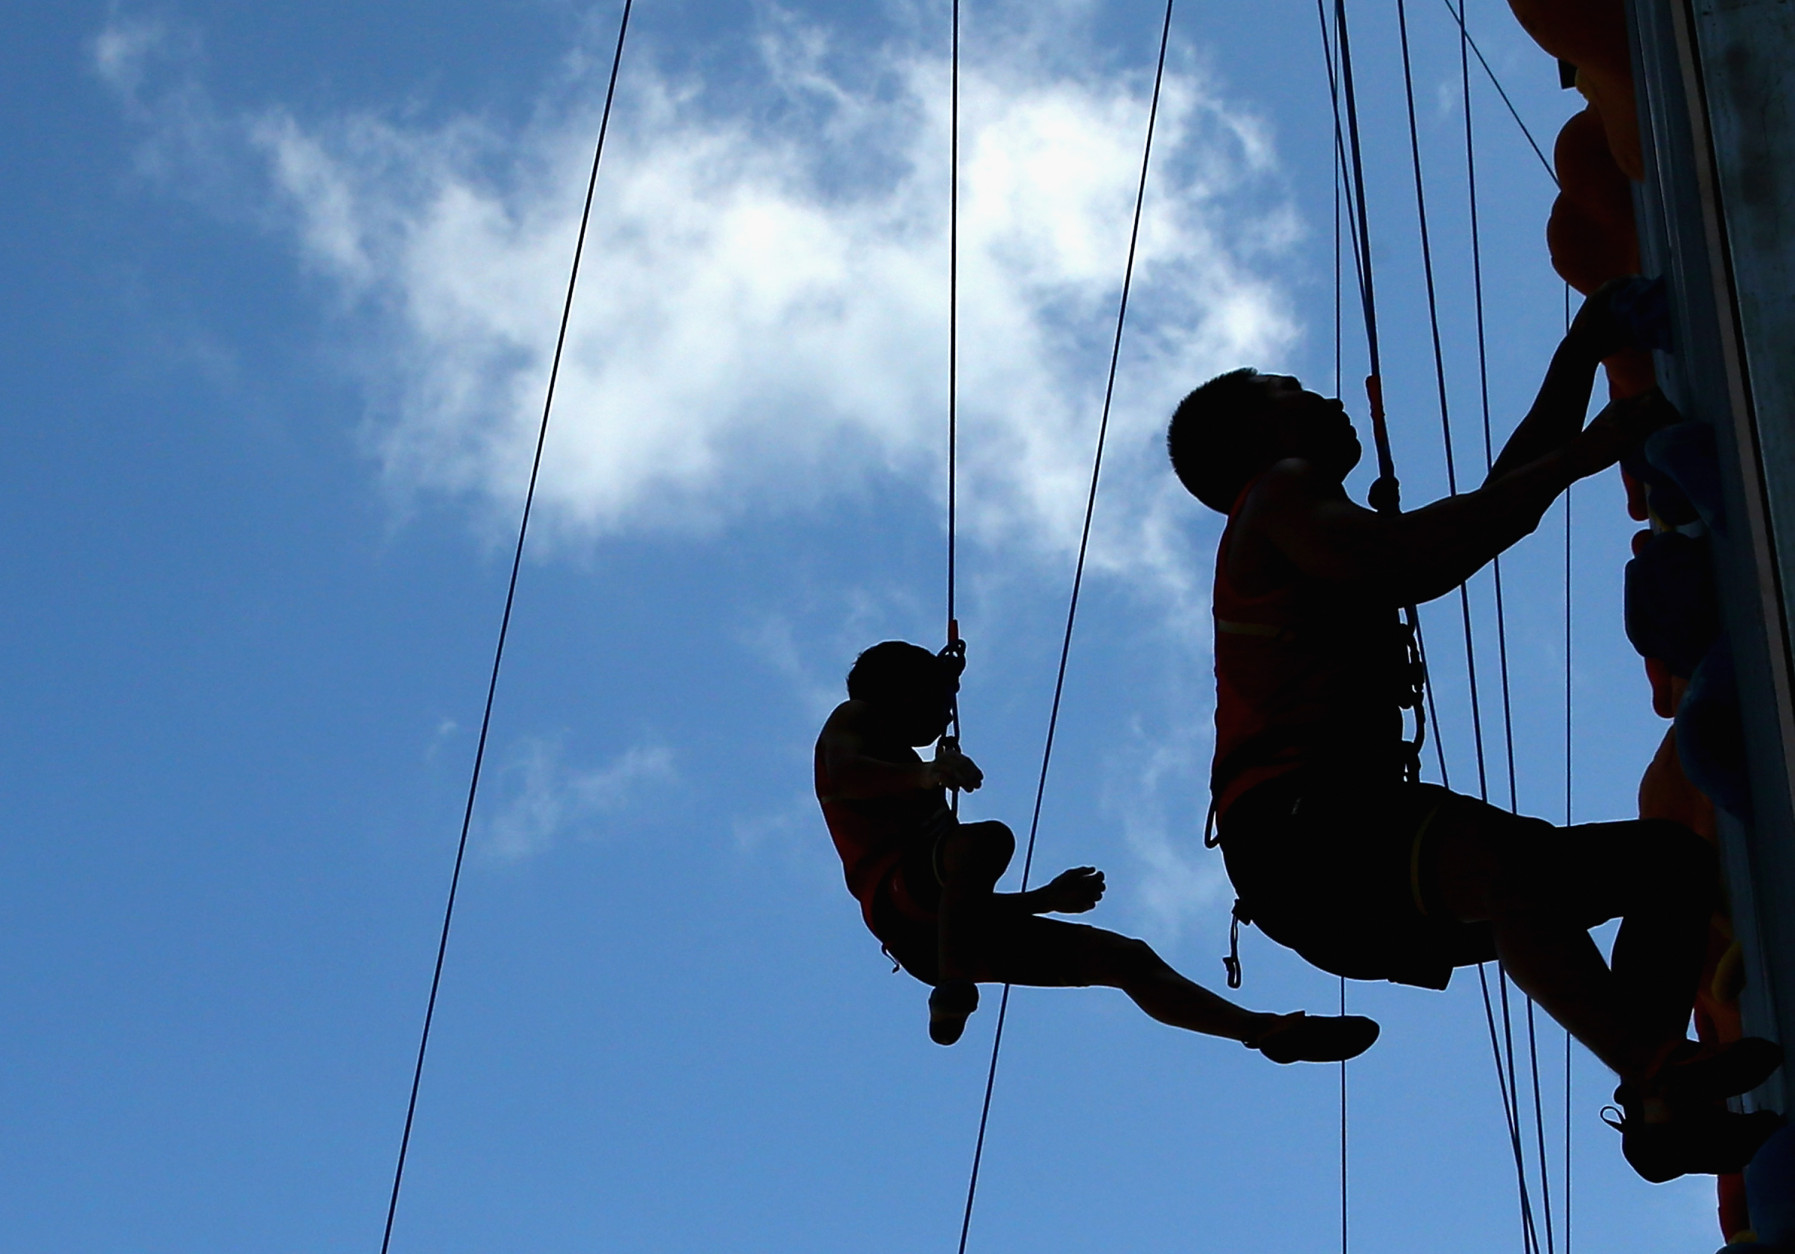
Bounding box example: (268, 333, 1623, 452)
(95, 5, 1296, 592)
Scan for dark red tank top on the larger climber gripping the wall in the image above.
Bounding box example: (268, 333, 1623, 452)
(1210, 481, 1409, 818)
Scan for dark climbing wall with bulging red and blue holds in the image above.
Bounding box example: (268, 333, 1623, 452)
(1510, 0, 1795, 1249)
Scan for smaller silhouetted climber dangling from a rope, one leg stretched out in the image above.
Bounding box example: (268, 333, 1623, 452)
(817, 640, 1377, 1062)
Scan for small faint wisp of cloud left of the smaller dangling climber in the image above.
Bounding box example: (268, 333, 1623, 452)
(481, 737, 675, 861)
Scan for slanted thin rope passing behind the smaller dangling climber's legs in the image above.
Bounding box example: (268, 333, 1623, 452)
(955, 0, 1174, 1254)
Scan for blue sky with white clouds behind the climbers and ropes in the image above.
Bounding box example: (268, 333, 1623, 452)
(0, 0, 1718, 1252)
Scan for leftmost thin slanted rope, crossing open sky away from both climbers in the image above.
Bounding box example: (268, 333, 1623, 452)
(381, 9, 634, 1254)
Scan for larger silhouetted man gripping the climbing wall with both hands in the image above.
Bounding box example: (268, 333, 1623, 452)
(1167, 289, 1781, 1180)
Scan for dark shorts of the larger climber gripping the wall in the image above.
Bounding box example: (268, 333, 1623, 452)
(1219, 770, 1507, 988)
